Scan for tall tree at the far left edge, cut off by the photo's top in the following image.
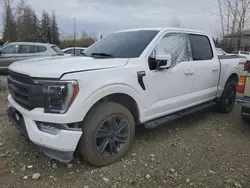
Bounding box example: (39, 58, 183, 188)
(2, 0, 17, 42)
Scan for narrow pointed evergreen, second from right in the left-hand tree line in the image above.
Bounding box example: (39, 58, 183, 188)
(40, 10, 52, 43)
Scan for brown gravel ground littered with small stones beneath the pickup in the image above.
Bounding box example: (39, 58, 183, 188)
(0, 75, 250, 188)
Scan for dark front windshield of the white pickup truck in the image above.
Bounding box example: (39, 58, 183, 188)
(84, 30, 159, 58)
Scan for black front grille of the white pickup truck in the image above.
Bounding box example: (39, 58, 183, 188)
(8, 72, 44, 110)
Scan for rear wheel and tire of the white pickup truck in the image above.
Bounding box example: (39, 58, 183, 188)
(217, 79, 238, 114)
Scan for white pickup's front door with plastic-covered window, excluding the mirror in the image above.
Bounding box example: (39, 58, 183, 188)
(144, 33, 194, 119)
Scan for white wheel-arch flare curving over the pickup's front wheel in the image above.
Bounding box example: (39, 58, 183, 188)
(80, 84, 143, 118)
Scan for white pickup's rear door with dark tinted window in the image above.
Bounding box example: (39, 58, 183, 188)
(189, 34, 220, 103)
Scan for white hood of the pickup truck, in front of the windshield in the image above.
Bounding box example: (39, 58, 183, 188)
(9, 56, 128, 78)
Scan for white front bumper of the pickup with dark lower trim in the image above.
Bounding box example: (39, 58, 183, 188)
(8, 96, 82, 163)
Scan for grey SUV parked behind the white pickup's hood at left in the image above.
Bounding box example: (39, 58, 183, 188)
(0, 42, 63, 73)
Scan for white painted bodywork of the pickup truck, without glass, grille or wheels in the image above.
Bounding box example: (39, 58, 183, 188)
(8, 28, 240, 151)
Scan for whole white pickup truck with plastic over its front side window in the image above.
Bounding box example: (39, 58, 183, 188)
(8, 28, 246, 166)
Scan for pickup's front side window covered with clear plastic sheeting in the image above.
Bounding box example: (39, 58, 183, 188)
(155, 33, 192, 67)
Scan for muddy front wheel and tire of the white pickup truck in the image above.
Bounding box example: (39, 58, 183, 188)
(78, 102, 135, 167)
